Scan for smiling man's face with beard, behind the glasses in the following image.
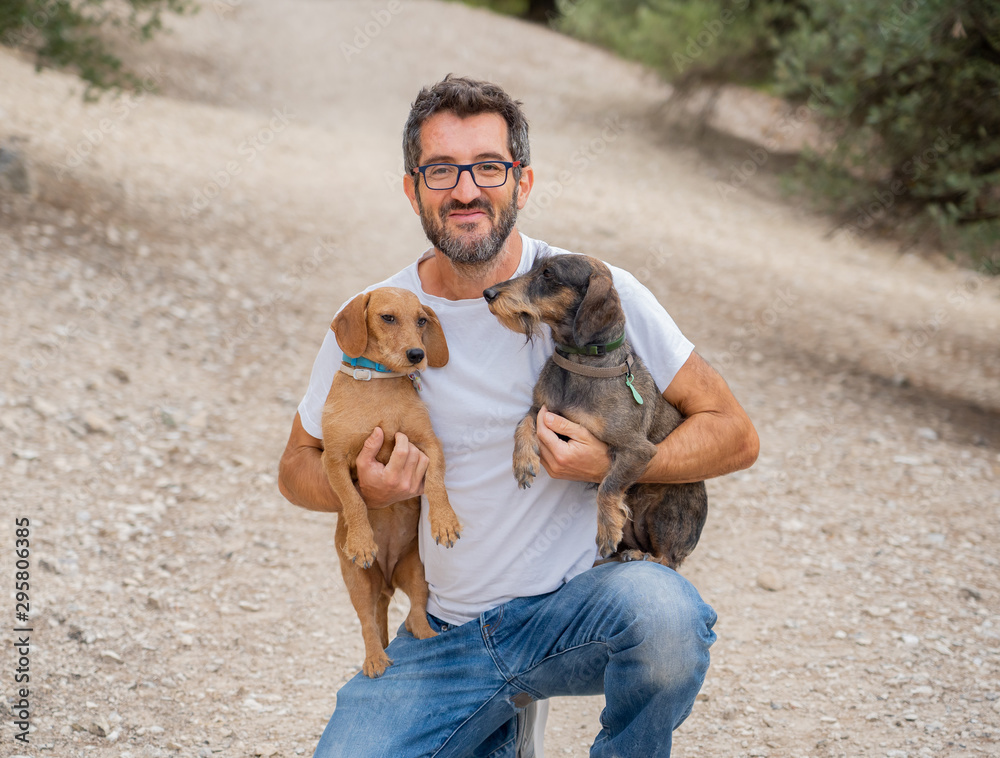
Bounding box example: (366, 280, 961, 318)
(404, 112, 531, 267)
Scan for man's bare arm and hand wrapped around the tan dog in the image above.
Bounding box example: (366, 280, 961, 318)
(278, 413, 428, 513)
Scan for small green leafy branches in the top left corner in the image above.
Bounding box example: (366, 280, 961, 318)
(0, 0, 194, 96)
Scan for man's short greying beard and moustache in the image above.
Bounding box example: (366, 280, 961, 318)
(417, 185, 518, 276)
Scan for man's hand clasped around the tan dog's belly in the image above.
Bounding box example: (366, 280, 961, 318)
(357, 427, 429, 508)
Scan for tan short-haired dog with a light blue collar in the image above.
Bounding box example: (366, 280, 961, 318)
(323, 287, 460, 677)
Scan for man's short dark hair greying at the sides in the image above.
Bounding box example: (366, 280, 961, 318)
(403, 74, 531, 178)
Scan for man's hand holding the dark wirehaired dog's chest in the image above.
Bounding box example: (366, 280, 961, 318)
(537, 405, 611, 482)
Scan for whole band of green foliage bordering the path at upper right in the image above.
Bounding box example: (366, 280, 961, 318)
(474, 0, 1000, 250)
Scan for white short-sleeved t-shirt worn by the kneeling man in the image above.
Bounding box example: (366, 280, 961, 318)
(299, 235, 693, 624)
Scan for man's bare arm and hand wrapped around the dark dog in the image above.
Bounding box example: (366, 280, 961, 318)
(538, 353, 760, 483)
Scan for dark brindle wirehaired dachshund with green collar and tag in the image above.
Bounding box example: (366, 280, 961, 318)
(483, 254, 708, 569)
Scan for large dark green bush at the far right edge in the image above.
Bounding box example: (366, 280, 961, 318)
(775, 0, 1000, 248)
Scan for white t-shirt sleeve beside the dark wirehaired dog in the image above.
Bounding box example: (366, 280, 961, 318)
(609, 266, 694, 392)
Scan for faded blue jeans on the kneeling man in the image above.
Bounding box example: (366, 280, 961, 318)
(315, 562, 716, 758)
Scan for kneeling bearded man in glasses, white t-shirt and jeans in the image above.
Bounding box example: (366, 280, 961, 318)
(279, 76, 757, 758)
